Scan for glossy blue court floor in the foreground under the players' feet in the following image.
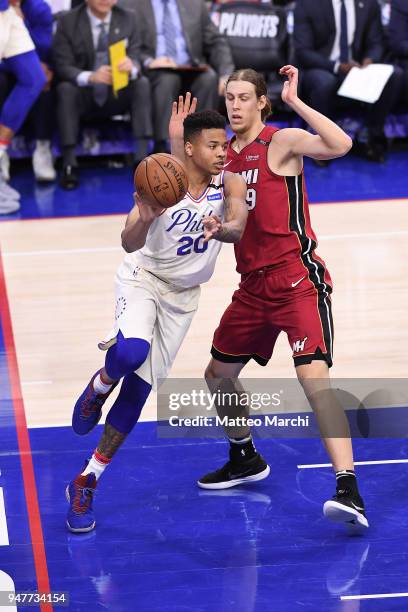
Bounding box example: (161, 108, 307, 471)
(1, 423, 408, 612)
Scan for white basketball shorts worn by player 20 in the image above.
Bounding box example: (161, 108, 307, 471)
(98, 262, 200, 390)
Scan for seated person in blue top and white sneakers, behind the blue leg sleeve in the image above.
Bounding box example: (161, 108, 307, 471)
(0, 0, 56, 181)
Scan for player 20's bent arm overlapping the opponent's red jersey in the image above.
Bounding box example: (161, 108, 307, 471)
(203, 172, 248, 243)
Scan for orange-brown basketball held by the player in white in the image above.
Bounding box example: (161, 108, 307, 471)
(134, 153, 188, 208)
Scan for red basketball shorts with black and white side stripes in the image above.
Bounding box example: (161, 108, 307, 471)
(211, 254, 333, 367)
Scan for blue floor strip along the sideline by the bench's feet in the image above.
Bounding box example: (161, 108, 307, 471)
(2, 151, 408, 220)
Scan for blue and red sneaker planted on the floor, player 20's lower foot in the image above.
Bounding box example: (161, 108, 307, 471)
(65, 472, 96, 533)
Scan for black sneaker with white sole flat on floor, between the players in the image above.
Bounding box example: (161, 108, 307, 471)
(197, 453, 270, 489)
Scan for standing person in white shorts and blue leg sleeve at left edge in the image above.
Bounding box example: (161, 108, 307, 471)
(0, 0, 45, 214)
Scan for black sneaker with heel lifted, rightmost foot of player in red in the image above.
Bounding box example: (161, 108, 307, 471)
(323, 488, 368, 531)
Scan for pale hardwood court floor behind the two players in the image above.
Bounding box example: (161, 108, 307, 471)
(0, 200, 408, 427)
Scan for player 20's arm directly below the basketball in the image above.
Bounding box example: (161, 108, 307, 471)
(122, 192, 166, 253)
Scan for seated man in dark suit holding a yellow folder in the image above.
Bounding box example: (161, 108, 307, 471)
(53, 0, 152, 189)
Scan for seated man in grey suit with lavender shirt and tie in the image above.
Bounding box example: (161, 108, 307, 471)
(136, 0, 234, 152)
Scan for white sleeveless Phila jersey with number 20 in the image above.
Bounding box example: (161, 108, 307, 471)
(125, 172, 224, 288)
